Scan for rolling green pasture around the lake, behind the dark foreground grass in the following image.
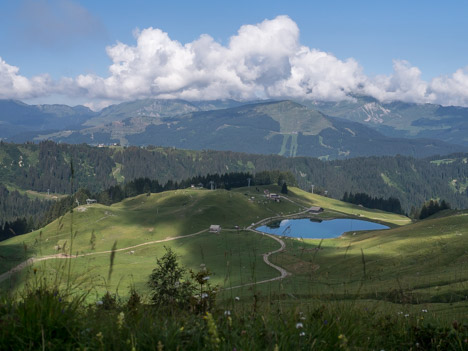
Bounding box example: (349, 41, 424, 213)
(0, 186, 468, 316)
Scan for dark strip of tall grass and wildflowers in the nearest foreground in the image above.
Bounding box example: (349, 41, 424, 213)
(0, 287, 468, 351)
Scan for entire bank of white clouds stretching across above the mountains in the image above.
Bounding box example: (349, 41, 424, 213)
(0, 16, 468, 108)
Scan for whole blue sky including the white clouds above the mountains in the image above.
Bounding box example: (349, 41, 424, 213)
(0, 0, 468, 110)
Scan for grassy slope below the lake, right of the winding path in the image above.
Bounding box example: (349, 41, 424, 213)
(266, 211, 468, 319)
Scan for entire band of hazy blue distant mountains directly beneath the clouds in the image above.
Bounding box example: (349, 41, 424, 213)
(0, 97, 468, 159)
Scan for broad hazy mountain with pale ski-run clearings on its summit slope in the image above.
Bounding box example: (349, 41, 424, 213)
(36, 100, 466, 160)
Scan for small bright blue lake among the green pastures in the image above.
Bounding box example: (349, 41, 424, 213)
(256, 218, 389, 239)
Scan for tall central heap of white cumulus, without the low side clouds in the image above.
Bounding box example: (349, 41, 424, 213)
(72, 16, 372, 100)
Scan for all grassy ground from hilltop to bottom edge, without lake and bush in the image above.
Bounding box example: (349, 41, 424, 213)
(0, 185, 468, 350)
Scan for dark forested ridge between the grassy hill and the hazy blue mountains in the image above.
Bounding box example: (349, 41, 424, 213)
(0, 141, 468, 235)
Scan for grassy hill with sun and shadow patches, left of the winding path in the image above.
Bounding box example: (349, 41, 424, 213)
(0, 186, 408, 296)
